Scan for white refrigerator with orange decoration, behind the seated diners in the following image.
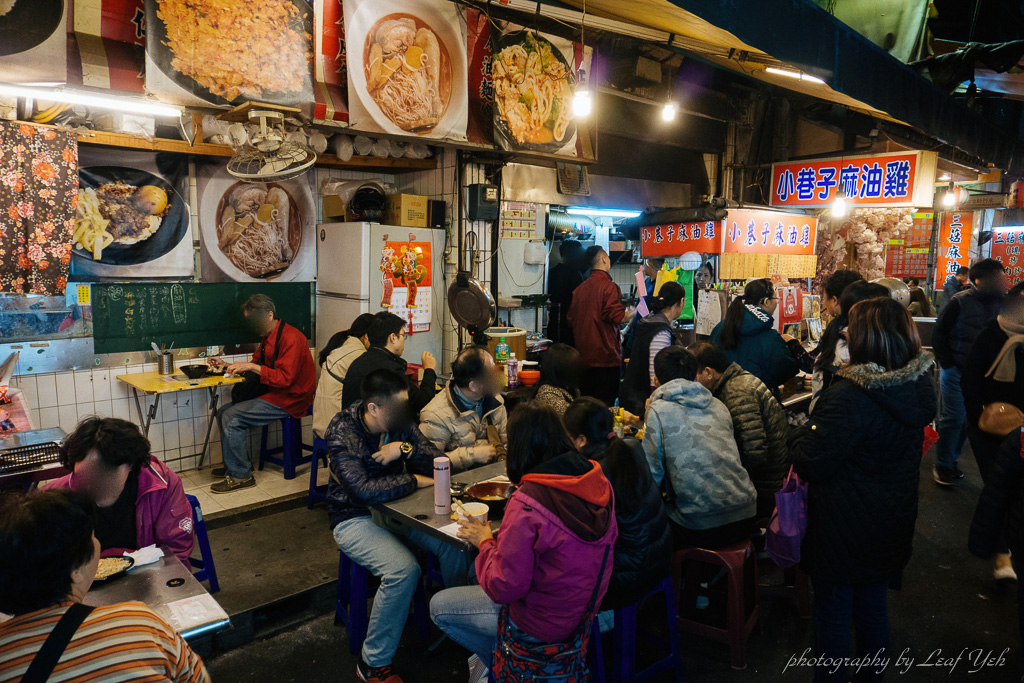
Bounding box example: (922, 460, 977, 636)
(316, 223, 446, 364)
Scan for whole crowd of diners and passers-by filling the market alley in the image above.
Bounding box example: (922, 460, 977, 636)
(0, 255, 1024, 683)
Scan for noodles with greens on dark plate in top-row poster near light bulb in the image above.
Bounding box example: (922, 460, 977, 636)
(492, 30, 575, 153)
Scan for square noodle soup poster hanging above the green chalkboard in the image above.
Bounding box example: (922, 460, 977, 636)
(196, 163, 316, 283)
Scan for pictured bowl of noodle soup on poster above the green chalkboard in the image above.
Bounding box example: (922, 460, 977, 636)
(201, 178, 315, 282)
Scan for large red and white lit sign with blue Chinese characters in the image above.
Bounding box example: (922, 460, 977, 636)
(771, 152, 935, 208)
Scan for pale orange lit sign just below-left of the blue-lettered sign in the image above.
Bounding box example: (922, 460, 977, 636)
(723, 209, 818, 256)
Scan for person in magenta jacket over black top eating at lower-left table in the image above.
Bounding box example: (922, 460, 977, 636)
(43, 418, 196, 567)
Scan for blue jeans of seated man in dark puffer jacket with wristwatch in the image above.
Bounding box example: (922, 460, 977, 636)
(334, 517, 468, 667)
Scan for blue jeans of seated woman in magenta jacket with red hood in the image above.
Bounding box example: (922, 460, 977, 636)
(430, 586, 501, 669)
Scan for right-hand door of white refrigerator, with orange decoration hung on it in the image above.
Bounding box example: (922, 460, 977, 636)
(369, 225, 446, 362)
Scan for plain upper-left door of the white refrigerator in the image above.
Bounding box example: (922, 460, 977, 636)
(316, 223, 372, 299)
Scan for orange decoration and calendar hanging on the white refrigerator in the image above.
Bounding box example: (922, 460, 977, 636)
(379, 241, 431, 333)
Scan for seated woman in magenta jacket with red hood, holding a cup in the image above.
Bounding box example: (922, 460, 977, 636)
(430, 401, 617, 668)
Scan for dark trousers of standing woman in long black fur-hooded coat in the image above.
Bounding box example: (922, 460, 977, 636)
(813, 579, 889, 683)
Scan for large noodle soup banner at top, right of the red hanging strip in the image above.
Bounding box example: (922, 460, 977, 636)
(344, 0, 468, 140)
